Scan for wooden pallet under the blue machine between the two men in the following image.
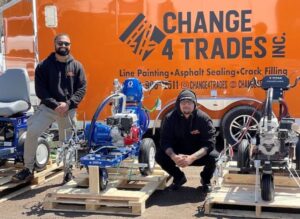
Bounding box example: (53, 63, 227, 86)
(43, 167, 168, 215)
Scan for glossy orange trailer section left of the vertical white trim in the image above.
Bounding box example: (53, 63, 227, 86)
(1, 0, 38, 79)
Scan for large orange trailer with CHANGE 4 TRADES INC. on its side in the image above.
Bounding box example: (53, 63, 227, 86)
(1, 0, 300, 143)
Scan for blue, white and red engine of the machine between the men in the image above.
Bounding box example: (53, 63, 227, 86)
(86, 113, 140, 147)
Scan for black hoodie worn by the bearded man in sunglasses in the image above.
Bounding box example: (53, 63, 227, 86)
(35, 53, 86, 110)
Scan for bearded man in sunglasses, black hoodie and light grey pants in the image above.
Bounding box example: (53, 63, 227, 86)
(12, 34, 86, 182)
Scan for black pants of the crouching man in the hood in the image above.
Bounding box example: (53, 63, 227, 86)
(155, 150, 219, 184)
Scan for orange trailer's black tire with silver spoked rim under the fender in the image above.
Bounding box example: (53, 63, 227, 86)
(220, 106, 261, 145)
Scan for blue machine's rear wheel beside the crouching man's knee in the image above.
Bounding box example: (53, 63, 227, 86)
(139, 138, 156, 176)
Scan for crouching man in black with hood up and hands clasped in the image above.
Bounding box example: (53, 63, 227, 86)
(155, 90, 218, 192)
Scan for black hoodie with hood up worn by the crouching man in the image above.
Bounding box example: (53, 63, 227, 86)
(161, 90, 216, 155)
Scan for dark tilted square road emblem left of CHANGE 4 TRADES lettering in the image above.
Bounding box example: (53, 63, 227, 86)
(119, 14, 166, 61)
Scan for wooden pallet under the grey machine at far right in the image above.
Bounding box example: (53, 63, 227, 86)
(204, 162, 300, 218)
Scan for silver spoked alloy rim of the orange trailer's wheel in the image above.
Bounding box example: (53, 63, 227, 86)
(229, 115, 258, 141)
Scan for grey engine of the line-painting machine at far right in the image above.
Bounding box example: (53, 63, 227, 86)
(258, 117, 298, 157)
